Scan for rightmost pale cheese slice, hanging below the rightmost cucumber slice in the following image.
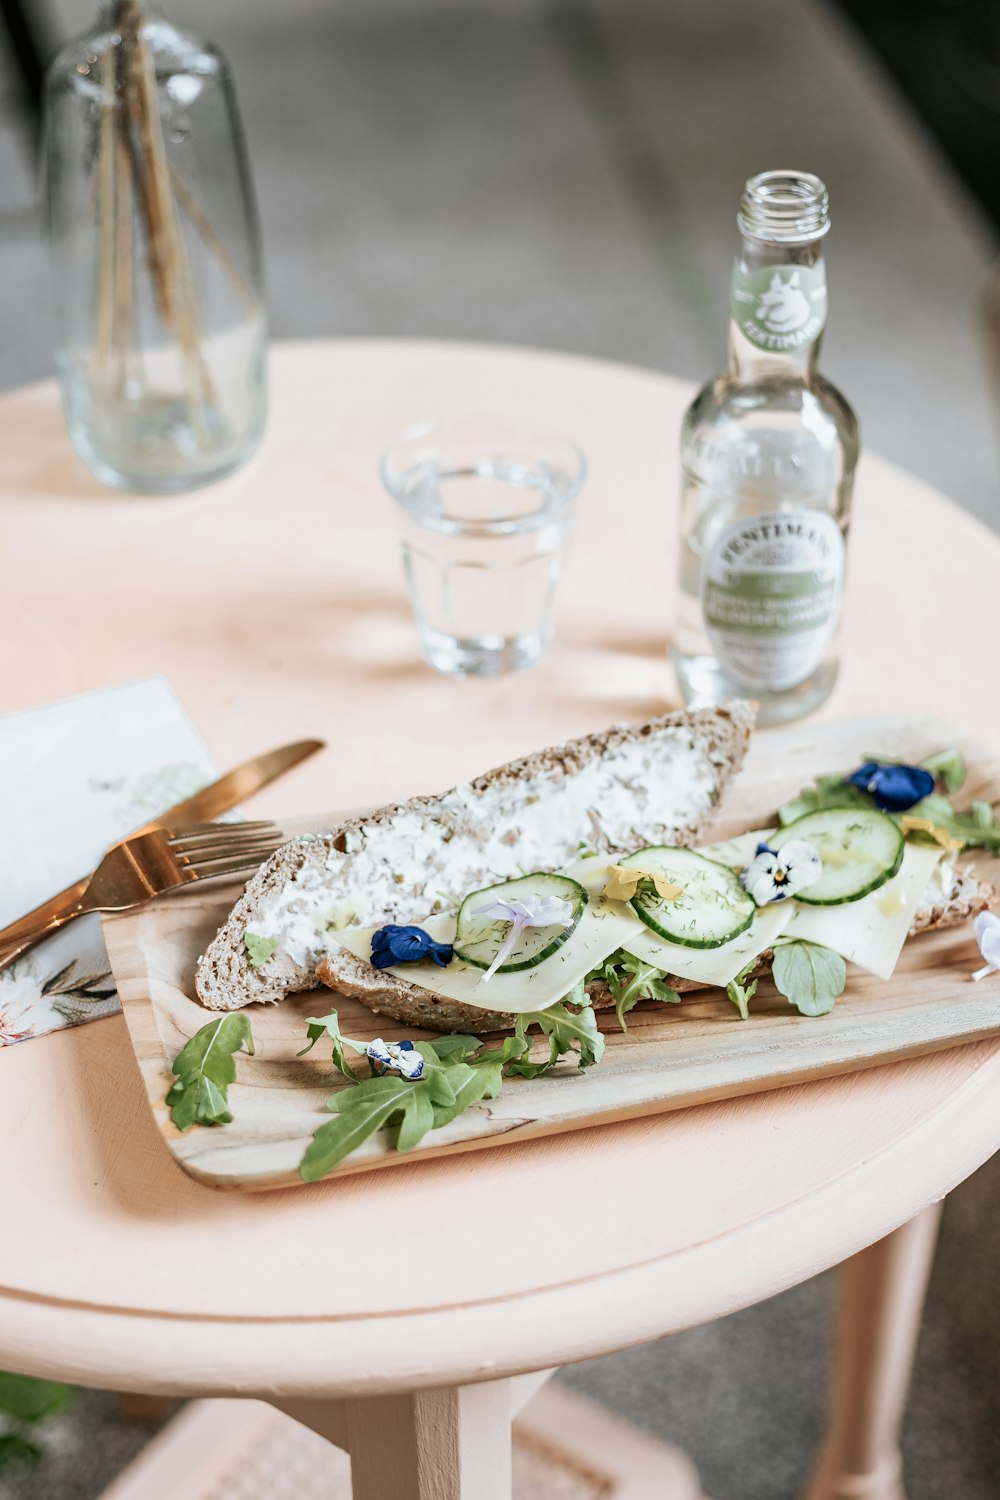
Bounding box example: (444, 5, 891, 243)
(786, 843, 945, 980)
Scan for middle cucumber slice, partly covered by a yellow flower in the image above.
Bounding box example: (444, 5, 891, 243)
(619, 845, 757, 948)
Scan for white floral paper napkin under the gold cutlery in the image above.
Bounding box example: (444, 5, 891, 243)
(0, 677, 217, 1047)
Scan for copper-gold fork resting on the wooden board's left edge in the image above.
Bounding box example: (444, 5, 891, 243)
(0, 822, 285, 969)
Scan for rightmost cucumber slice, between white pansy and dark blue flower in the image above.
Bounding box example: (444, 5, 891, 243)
(769, 807, 906, 906)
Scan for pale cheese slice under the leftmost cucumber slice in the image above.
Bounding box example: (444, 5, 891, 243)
(337, 897, 642, 1016)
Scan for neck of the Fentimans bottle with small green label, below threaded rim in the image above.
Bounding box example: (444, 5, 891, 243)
(727, 237, 826, 384)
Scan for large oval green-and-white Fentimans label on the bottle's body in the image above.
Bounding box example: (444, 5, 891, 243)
(702, 510, 844, 692)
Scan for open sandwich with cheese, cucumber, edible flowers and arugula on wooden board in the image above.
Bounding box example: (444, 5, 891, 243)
(177, 702, 1000, 1179)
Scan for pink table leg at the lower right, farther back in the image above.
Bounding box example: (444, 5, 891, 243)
(804, 1203, 942, 1500)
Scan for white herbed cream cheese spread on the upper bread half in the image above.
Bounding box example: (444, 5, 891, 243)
(249, 728, 718, 968)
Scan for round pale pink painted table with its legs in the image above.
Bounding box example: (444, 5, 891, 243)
(0, 341, 1000, 1500)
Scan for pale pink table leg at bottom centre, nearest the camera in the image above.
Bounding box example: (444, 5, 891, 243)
(345, 1380, 511, 1500)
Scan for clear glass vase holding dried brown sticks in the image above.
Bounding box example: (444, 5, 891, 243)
(45, 0, 267, 492)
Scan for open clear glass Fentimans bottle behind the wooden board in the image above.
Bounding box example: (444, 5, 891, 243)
(670, 171, 859, 725)
